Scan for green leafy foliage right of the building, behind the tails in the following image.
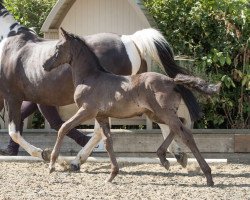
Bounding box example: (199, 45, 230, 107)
(145, 0, 250, 128)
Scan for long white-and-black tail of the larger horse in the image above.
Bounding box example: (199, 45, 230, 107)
(130, 28, 202, 121)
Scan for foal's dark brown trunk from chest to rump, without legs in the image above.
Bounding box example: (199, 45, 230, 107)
(78, 72, 180, 118)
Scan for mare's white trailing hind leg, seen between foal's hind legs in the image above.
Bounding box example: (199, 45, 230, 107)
(158, 123, 187, 168)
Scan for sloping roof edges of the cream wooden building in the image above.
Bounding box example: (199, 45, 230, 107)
(41, 0, 156, 32)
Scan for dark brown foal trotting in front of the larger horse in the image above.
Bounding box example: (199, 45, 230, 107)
(43, 29, 219, 186)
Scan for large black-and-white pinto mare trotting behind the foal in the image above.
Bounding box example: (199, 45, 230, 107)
(0, 0, 197, 166)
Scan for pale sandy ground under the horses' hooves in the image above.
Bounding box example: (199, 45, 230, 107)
(0, 162, 250, 200)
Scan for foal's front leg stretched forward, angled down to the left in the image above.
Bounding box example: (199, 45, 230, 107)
(49, 107, 97, 173)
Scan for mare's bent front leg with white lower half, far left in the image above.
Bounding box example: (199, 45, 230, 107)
(6, 99, 42, 158)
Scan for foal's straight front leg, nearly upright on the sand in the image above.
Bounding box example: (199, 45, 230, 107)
(97, 118, 119, 182)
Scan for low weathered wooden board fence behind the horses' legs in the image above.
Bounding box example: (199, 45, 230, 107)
(0, 129, 250, 155)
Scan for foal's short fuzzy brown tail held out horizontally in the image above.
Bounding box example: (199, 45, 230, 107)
(174, 74, 221, 95)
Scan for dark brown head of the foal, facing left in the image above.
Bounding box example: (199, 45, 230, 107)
(43, 28, 74, 71)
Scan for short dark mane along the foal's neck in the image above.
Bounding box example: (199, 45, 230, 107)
(68, 33, 111, 73)
